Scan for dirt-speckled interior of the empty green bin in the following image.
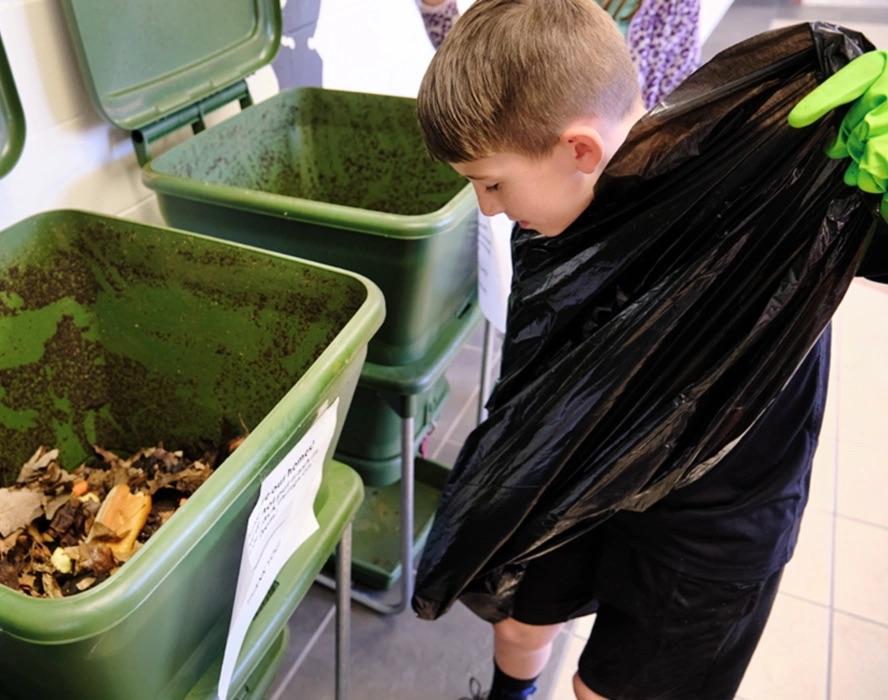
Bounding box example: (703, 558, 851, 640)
(152, 90, 466, 216)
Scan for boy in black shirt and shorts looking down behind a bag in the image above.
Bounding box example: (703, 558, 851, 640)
(418, 0, 888, 700)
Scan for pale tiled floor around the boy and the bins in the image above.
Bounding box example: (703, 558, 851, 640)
(272, 0, 888, 700)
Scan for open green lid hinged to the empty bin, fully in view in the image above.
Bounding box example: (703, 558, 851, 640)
(63, 0, 281, 131)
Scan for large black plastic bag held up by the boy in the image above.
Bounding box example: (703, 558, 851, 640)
(413, 23, 878, 621)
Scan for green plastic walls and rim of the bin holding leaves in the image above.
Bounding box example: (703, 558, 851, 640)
(0, 212, 383, 700)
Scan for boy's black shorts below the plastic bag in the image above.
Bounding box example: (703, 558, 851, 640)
(512, 526, 782, 700)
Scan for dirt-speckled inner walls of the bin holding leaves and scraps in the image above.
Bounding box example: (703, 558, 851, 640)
(0, 218, 366, 486)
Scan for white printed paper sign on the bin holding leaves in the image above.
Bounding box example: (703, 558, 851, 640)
(218, 398, 339, 700)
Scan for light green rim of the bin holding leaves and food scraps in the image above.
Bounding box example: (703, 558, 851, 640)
(0, 209, 384, 645)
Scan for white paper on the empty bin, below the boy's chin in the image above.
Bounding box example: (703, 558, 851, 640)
(478, 212, 513, 333)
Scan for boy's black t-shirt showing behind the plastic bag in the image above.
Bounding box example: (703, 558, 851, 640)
(605, 220, 888, 581)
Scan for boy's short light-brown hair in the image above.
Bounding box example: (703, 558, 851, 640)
(417, 0, 639, 163)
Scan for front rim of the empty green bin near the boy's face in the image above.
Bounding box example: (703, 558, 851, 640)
(142, 161, 477, 239)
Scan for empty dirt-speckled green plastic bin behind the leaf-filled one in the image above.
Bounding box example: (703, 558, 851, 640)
(144, 88, 477, 365)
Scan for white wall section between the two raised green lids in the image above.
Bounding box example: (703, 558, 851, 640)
(0, 0, 159, 229)
